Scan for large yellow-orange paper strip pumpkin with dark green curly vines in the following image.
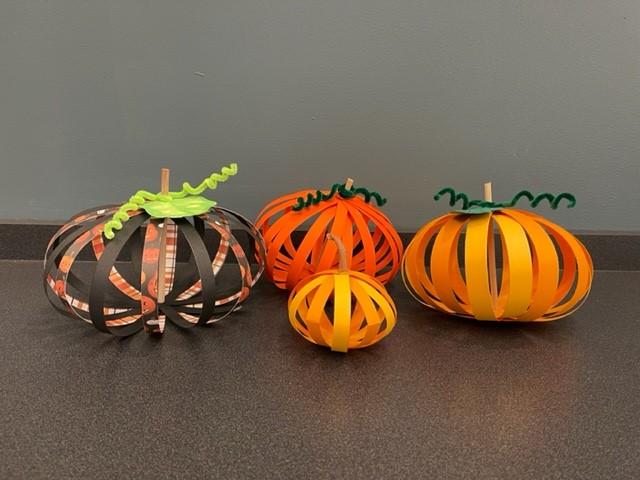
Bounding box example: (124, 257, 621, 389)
(402, 184, 593, 321)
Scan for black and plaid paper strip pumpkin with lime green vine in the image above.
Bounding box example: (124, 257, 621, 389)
(44, 164, 265, 336)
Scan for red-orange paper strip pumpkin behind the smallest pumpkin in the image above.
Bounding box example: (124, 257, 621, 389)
(256, 179, 402, 289)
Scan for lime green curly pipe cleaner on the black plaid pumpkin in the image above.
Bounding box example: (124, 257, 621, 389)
(104, 163, 238, 240)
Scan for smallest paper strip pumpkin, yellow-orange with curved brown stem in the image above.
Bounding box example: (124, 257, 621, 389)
(289, 233, 397, 352)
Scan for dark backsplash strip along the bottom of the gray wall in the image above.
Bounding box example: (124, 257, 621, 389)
(0, 223, 640, 271)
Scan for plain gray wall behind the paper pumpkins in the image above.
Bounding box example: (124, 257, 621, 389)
(0, 0, 640, 231)
